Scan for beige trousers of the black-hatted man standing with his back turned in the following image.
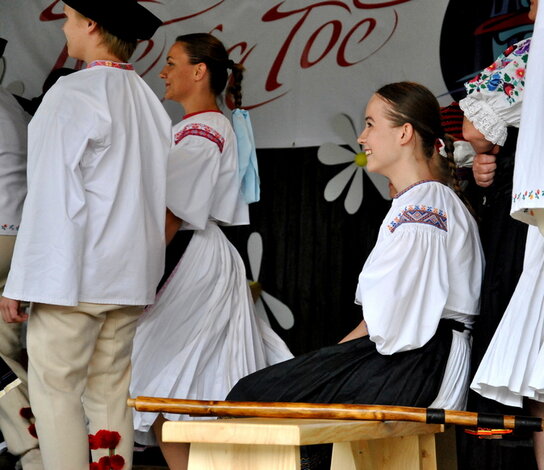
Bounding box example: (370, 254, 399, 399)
(27, 303, 142, 470)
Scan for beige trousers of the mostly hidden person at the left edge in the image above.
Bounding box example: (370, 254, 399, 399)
(0, 235, 43, 470)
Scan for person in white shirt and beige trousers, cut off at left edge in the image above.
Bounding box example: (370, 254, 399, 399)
(0, 38, 43, 470)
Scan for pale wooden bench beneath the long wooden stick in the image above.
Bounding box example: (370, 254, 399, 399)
(163, 418, 456, 470)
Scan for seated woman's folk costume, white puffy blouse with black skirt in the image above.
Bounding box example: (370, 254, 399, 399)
(228, 181, 483, 409)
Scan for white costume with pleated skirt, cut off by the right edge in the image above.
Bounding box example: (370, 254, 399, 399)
(471, 11, 544, 407)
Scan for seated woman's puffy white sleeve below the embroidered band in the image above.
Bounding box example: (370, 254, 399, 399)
(356, 223, 449, 354)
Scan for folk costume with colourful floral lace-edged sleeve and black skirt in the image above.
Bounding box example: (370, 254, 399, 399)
(454, 39, 533, 414)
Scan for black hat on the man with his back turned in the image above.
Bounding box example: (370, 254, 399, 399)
(63, 0, 162, 41)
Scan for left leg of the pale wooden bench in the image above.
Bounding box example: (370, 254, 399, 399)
(188, 443, 300, 470)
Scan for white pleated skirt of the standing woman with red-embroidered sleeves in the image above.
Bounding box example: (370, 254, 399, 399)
(130, 222, 293, 444)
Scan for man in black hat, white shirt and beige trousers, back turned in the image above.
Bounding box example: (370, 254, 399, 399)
(0, 0, 171, 470)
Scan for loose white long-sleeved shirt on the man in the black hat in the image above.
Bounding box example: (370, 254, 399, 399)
(4, 63, 171, 305)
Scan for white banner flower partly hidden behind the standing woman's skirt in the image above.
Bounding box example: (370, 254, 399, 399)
(247, 232, 295, 330)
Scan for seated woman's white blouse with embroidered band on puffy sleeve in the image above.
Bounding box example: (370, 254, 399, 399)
(356, 181, 484, 354)
